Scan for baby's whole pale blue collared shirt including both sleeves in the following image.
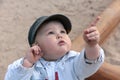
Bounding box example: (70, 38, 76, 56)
(5, 49, 104, 80)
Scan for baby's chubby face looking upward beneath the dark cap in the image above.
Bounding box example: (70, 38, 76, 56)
(36, 21, 71, 61)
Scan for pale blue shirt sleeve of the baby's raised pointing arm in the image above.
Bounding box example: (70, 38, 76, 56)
(74, 48, 104, 79)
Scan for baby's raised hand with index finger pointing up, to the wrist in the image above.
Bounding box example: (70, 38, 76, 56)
(83, 17, 100, 46)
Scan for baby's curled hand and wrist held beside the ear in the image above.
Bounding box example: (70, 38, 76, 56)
(23, 45, 43, 67)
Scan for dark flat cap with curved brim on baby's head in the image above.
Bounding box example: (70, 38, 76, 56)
(28, 14, 72, 46)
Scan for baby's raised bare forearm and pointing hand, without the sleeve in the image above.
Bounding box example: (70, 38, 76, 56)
(83, 18, 100, 60)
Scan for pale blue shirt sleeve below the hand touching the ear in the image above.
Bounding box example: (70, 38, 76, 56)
(5, 58, 34, 80)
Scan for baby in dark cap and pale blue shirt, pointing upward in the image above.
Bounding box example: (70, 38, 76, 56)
(5, 14, 104, 80)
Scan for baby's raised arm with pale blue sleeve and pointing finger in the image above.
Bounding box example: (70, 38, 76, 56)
(74, 16, 104, 79)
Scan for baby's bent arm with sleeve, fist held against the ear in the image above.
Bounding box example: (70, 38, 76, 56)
(5, 45, 42, 80)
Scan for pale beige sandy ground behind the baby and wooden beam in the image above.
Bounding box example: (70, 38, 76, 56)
(0, 0, 120, 80)
